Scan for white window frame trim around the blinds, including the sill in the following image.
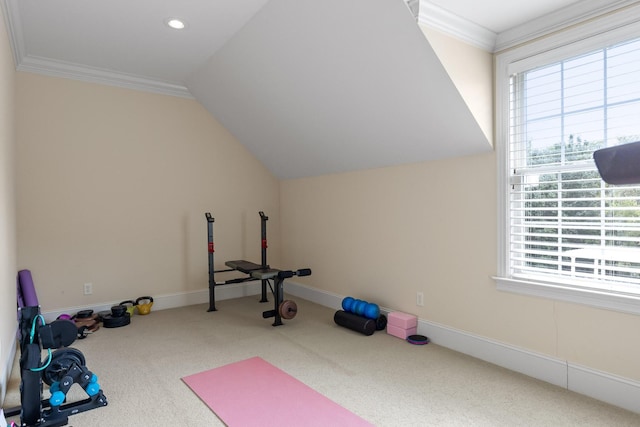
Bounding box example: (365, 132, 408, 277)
(494, 6, 640, 314)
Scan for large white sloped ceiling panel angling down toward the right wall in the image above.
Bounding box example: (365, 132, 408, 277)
(187, 0, 491, 179)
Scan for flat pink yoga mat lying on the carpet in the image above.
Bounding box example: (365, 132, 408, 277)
(182, 357, 373, 427)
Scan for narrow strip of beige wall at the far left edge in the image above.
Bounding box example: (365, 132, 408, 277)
(0, 5, 17, 402)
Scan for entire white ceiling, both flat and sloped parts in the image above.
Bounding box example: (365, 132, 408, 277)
(2, 0, 604, 179)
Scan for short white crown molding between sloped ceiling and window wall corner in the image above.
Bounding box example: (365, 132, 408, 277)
(418, 0, 498, 52)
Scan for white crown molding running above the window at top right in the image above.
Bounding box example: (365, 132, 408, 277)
(494, 0, 638, 52)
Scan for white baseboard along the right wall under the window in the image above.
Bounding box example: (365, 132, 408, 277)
(286, 281, 640, 413)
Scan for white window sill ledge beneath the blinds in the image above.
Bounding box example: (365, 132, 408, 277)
(493, 277, 640, 314)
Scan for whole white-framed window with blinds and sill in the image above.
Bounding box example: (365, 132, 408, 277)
(497, 13, 640, 313)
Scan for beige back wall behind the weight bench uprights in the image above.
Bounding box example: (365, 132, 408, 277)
(16, 73, 279, 311)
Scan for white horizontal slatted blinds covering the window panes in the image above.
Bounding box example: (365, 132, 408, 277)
(508, 39, 640, 293)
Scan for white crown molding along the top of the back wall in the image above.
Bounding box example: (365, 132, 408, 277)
(17, 56, 194, 99)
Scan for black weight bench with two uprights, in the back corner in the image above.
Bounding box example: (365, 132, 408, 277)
(205, 211, 311, 326)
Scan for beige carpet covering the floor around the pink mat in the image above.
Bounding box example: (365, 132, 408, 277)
(3, 297, 640, 427)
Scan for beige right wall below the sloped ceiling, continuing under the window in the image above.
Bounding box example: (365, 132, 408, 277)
(280, 35, 640, 380)
